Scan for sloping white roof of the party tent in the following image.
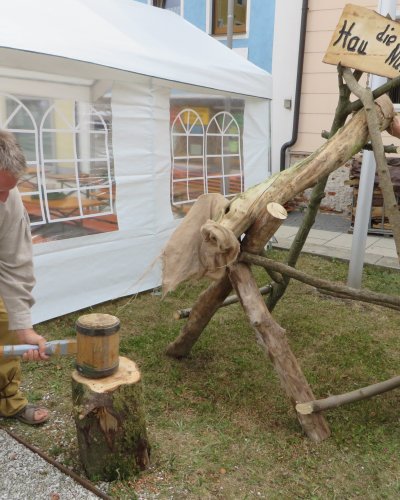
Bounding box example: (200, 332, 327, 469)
(0, 0, 272, 98)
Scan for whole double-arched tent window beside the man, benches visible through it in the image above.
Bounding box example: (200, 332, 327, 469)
(0, 94, 118, 242)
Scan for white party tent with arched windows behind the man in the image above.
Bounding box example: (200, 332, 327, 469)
(0, 0, 272, 322)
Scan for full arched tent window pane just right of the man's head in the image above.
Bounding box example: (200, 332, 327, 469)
(40, 100, 113, 222)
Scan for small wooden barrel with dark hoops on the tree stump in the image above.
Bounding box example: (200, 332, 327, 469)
(76, 314, 120, 378)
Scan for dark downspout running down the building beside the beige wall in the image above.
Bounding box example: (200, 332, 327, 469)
(280, 0, 308, 172)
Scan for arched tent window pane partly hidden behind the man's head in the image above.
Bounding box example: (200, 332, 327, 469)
(0, 94, 45, 226)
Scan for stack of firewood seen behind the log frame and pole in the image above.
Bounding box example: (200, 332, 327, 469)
(346, 158, 400, 234)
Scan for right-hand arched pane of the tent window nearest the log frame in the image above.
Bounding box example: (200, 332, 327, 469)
(206, 111, 243, 198)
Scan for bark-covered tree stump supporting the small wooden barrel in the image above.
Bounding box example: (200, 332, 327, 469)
(72, 357, 150, 481)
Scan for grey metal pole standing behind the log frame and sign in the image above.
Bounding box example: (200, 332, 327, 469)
(347, 0, 396, 288)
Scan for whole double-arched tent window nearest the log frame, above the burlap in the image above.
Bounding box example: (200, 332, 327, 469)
(171, 98, 244, 216)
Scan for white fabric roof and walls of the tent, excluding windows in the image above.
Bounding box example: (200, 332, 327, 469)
(0, 0, 271, 322)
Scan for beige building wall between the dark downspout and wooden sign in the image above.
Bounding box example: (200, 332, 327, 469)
(290, 0, 400, 156)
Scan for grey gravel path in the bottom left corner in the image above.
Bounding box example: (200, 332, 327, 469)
(0, 429, 99, 500)
